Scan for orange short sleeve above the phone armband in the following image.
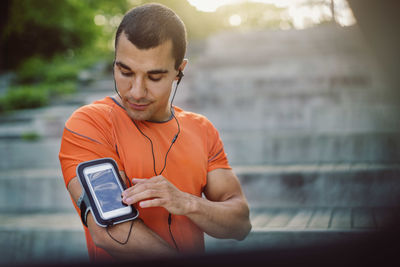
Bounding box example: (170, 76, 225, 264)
(59, 106, 122, 186)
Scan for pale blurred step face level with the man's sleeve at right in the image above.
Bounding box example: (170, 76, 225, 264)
(221, 130, 400, 165)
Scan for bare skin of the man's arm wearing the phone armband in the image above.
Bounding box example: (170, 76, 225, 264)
(68, 177, 176, 259)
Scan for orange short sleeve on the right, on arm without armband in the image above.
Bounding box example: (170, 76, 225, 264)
(207, 122, 231, 172)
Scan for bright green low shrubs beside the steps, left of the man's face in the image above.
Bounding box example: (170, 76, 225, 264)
(0, 48, 111, 112)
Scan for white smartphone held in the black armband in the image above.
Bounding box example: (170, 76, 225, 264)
(83, 162, 133, 220)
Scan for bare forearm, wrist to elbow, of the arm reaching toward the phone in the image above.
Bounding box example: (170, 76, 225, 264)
(187, 195, 251, 240)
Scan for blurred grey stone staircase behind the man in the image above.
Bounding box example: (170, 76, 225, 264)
(0, 25, 400, 264)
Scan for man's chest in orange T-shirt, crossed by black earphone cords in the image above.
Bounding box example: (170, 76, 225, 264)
(114, 120, 208, 196)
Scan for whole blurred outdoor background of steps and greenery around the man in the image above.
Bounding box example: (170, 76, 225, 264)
(0, 0, 400, 264)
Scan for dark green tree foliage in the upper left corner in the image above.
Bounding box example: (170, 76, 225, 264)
(1, 0, 101, 69)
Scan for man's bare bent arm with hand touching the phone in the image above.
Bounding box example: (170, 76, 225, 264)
(123, 169, 251, 240)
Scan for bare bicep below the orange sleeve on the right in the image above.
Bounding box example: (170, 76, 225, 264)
(204, 169, 244, 201)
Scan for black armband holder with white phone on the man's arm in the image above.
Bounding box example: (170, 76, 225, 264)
(76, 158, 139, 227)
